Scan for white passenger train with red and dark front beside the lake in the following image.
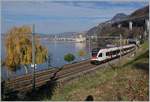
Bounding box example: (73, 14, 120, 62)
(91, 44, 136, 64)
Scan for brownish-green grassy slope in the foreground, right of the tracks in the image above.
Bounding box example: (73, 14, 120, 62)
(44, 42, 149, 101)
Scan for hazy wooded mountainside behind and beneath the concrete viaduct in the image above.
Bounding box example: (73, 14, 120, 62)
(86, 6, 149, 46)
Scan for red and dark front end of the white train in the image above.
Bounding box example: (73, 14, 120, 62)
(91, 48, 100, 64)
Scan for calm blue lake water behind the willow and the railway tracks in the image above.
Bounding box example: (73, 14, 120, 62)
(1, 37, 90, 79)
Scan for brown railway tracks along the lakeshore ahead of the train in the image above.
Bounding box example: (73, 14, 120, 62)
(4, 49, 135, 92)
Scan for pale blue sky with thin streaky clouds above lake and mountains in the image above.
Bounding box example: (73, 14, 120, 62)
(1, 0, 148, 34)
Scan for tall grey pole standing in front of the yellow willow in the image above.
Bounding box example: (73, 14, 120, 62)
(32, 24, 35, 90)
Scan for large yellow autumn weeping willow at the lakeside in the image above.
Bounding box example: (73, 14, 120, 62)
(5, 26, 48, 69)
